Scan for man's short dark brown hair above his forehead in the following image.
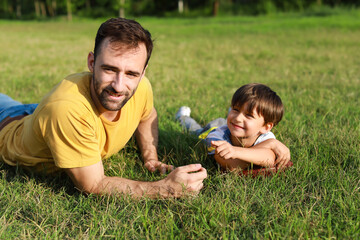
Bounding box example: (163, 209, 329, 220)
(94, 18, 153, 66)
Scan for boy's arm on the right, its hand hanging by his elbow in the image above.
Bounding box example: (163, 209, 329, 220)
(253, 139, 291, 168)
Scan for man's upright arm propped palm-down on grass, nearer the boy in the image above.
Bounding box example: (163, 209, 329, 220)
(135, 108, 174, 173)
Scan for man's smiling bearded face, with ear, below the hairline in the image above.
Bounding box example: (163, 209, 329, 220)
(88, 39, 147, 117)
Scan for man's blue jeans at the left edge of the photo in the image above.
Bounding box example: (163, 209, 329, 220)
(0, 93, 38, 122)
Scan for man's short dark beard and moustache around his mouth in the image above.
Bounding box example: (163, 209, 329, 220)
(93, 73, 135, 111)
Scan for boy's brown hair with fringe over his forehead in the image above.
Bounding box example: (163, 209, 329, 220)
(231, 83, 284, 126)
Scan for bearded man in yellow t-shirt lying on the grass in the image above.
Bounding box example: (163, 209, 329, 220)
(0, 18, 207, 198)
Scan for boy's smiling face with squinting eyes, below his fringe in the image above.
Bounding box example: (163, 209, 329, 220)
(227, 104, 273, 147)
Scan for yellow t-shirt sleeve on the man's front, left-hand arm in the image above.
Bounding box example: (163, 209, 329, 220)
(39, 102, 101, 168)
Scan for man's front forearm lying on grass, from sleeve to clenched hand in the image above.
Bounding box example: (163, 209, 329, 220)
(65, 161, 207, 198)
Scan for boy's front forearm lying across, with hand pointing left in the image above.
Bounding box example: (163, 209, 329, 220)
(211, 141, 275, 170)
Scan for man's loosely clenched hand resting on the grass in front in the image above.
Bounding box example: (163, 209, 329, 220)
(163, 164, 207, 197)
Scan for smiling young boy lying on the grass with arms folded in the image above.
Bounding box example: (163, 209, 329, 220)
(176, 83, 292, 171)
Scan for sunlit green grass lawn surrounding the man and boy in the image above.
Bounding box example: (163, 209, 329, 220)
(0, 11, 360, 239)
